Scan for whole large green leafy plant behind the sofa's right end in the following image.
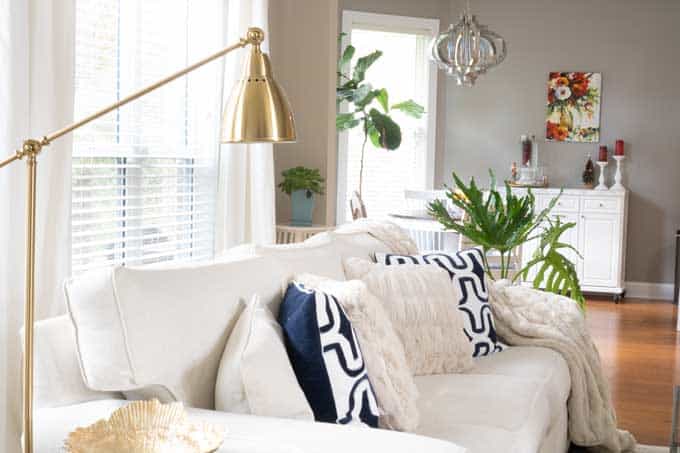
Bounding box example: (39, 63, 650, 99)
(429, 171, 584, 306)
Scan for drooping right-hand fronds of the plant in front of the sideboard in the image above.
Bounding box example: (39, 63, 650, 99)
(515, 217, 586, 309)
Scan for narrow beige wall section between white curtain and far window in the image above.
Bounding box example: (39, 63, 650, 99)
(269, 0, 338, 224)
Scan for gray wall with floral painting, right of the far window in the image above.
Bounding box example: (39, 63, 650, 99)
(438, 0, 680, 283)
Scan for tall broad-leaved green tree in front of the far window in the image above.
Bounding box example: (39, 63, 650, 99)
(335, 33, 425, 197)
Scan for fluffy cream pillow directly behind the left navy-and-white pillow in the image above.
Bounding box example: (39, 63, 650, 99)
(295, 274, 419, 431)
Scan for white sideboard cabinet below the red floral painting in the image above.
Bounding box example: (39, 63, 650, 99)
(516, 188, 628, 302)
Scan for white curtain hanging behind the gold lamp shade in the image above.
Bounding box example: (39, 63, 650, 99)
(215, 0, 276, 252)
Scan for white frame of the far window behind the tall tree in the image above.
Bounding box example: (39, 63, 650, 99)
(335, 10, 440, 224)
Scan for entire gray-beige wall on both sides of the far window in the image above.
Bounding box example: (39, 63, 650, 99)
(270, 0, 680, 283)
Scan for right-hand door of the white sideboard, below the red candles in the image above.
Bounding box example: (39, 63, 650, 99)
(579, 213, 621, 287)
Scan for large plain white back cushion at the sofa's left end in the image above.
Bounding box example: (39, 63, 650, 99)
(66, 257, 285, 408)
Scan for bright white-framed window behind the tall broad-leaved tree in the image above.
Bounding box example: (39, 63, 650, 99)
(337, 11, 439, 223)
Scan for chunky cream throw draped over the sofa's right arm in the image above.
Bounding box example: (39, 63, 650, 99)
(489, 280, 635, 453)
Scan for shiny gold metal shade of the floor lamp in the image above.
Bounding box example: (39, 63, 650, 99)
(222, 28, 295, 143)
